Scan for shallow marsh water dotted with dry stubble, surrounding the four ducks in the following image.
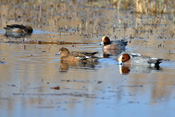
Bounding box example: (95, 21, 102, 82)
(0, 0, 175, 117)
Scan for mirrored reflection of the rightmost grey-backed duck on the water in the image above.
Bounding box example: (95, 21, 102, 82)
(119, 65, 162, 75)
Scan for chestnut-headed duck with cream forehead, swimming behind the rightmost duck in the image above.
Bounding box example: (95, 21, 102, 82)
(101, 36, 128, 55)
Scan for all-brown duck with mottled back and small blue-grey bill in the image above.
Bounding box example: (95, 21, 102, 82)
(57, 47, 99, 62)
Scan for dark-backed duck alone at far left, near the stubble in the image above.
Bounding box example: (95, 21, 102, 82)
(4, 24, 33, 34)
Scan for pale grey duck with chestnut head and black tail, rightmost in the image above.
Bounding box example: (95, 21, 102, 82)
(116, 52, 163, 67)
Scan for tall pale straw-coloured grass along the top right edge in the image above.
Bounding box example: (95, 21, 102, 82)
(109, 0, 175, 14)
